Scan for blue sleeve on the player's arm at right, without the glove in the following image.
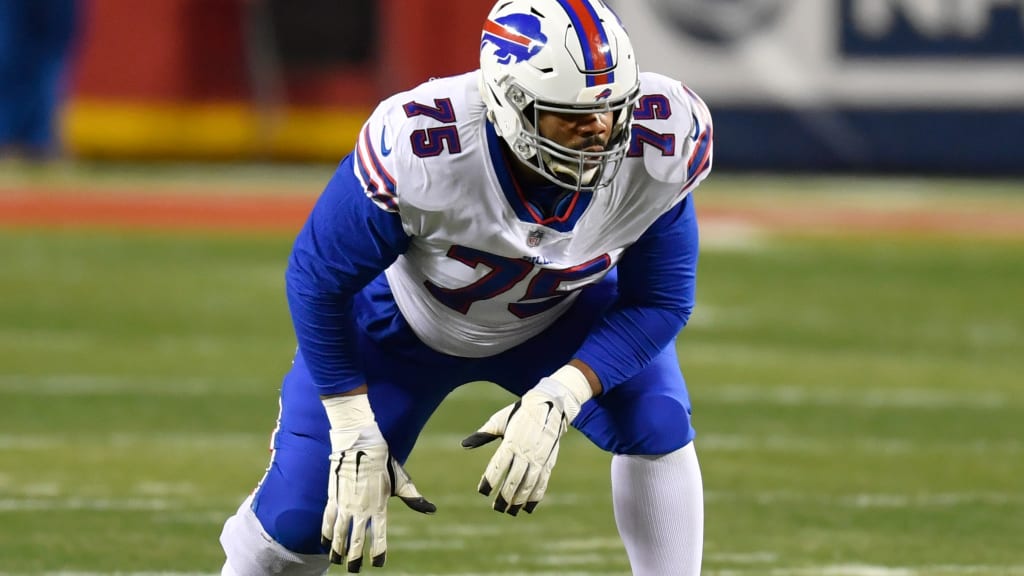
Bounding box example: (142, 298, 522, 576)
(577, 195, 699, 392)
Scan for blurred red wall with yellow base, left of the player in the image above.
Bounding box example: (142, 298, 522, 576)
(62, 0, 488, 161)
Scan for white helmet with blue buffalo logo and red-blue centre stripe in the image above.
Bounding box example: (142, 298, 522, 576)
(480, 0, 640, 190)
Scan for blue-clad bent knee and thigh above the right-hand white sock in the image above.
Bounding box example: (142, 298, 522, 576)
(573, 344, 694, 454)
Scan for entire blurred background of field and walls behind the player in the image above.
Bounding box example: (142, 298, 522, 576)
(0, 0, 1024, 576)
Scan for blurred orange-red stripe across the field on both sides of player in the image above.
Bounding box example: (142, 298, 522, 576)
(0, 188, 1024, 235)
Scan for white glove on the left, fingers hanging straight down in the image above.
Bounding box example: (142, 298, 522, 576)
(321, 394, 437, 572)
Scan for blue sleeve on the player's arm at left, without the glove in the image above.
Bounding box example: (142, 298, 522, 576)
(286, 156, 410, 395)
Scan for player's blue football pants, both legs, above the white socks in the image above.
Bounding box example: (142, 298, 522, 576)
(253, 271, 694, 553)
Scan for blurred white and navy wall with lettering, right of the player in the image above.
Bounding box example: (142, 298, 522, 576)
(613, 0, 1024, 173)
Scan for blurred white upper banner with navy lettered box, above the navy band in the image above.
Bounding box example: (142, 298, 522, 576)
(607, 0, 1024, 109)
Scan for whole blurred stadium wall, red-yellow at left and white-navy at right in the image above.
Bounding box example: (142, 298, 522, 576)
(66, 0, 1024, 174)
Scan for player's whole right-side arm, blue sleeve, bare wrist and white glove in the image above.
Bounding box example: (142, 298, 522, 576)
(462, 197, 697, 516)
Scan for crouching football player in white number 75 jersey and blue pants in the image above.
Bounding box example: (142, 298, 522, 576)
(221, 0, 712, 576)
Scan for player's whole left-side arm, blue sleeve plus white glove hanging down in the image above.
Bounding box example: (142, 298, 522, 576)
(286, 147, 435, 572)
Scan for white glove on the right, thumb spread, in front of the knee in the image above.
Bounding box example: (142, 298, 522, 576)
(462, 365, 593, 516)
